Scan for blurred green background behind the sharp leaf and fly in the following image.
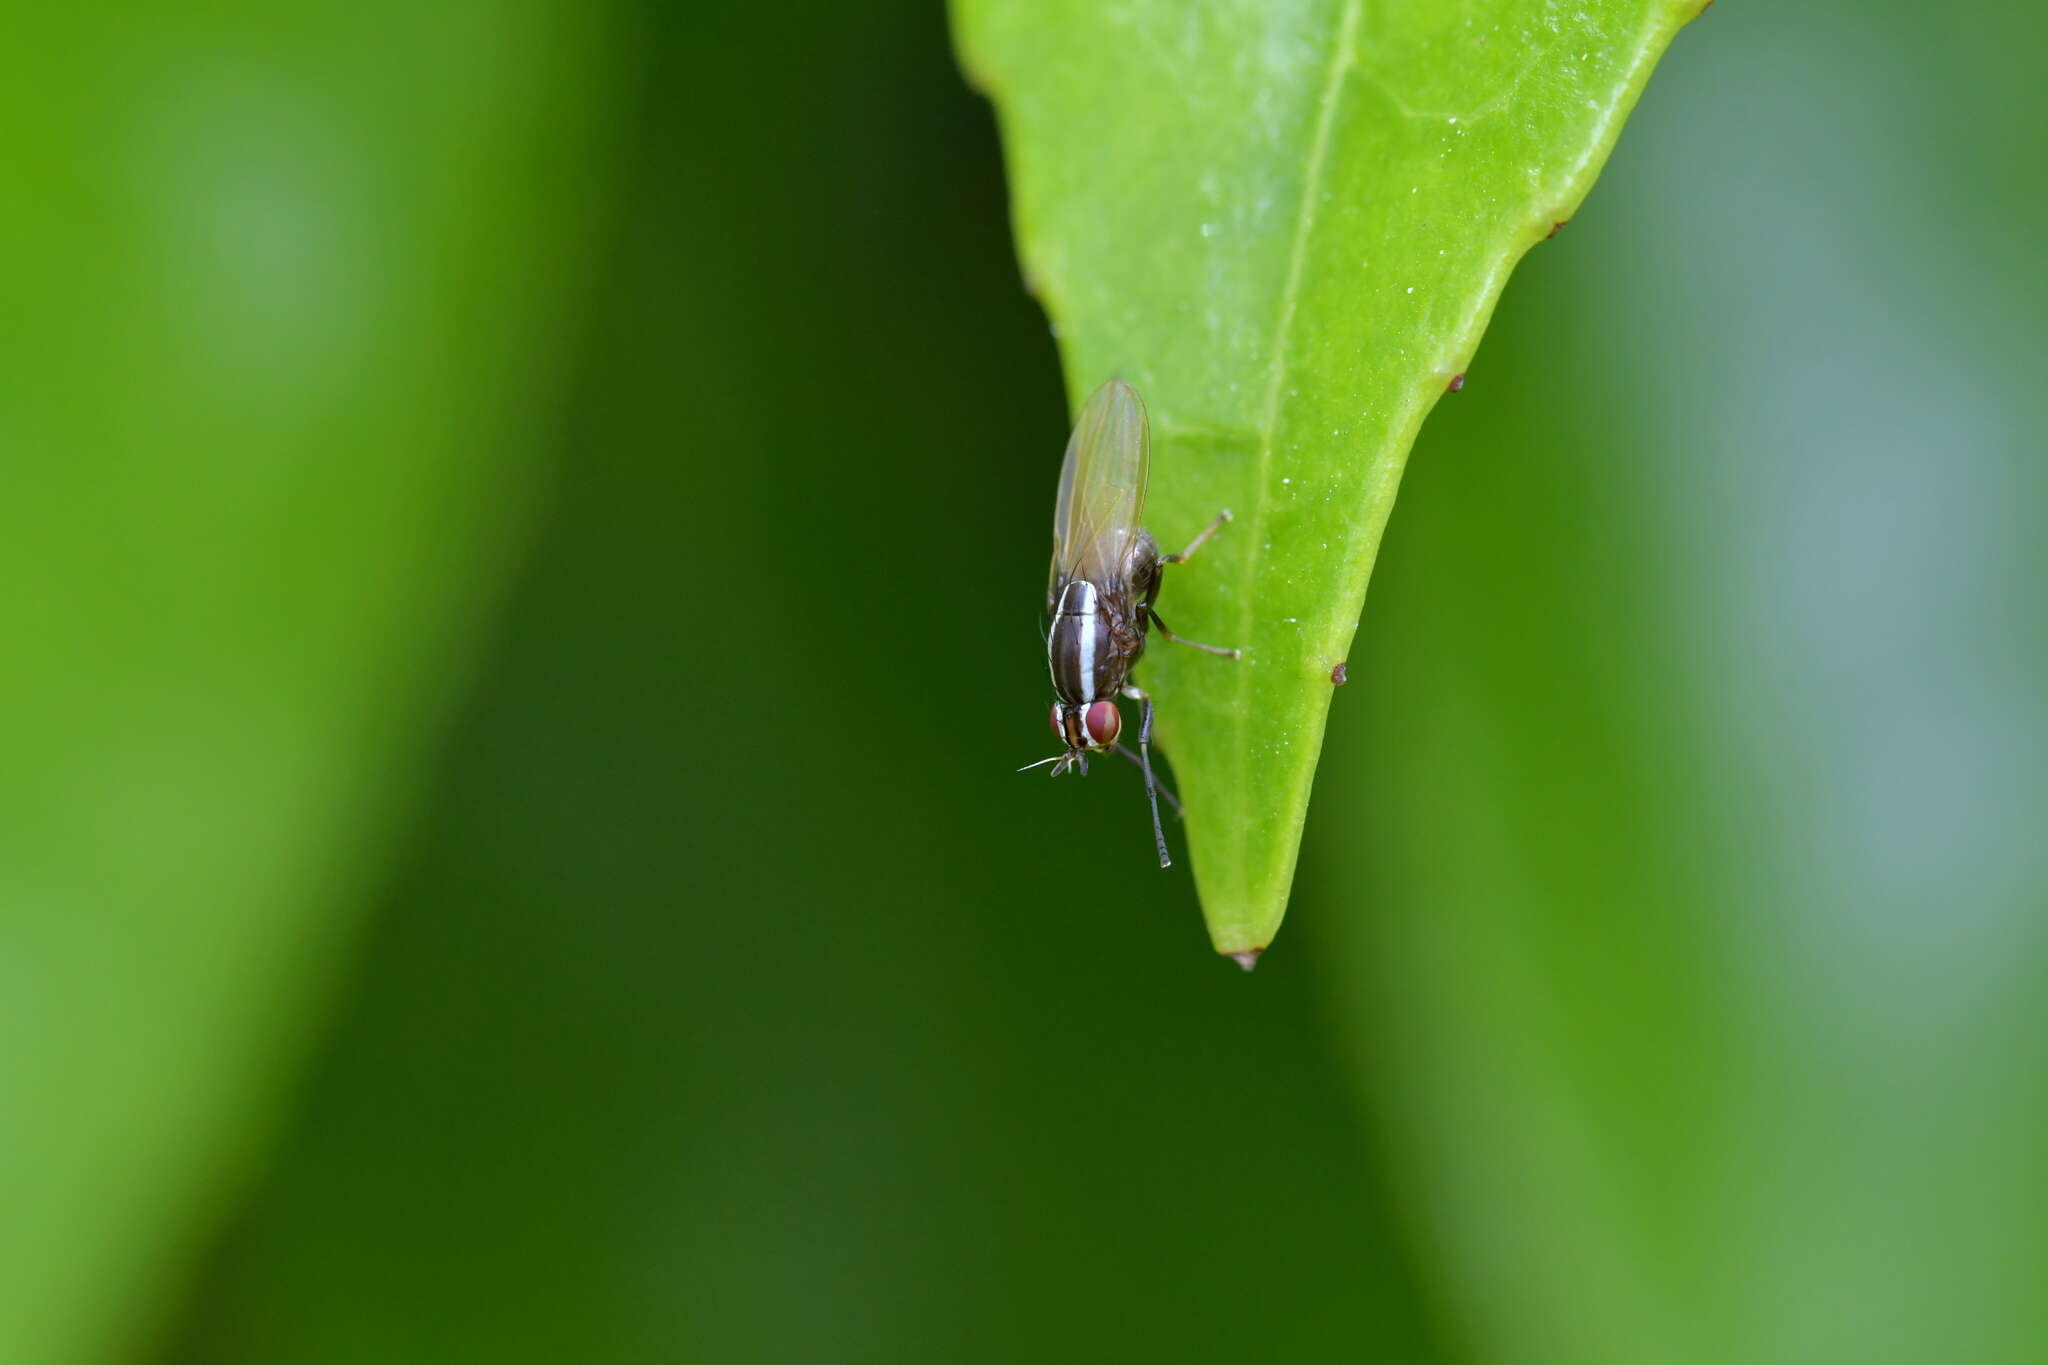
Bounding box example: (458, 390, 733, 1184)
(0, 0, 2048, 1365)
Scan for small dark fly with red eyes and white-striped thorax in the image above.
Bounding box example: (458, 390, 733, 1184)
(1030, 379, 1237, 868)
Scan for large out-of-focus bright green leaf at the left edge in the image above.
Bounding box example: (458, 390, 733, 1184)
(0, 0, 610, 1365)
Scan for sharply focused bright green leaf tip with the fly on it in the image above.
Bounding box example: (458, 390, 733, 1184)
(954, 0, 1700, 966)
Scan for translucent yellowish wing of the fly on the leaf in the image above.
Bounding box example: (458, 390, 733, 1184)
(1053, 379, 1151, 601)
